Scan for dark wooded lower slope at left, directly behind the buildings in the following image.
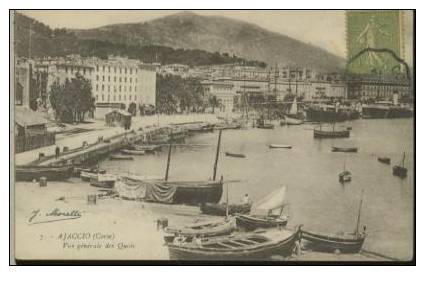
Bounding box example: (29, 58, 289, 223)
(14, 13, 265, 66)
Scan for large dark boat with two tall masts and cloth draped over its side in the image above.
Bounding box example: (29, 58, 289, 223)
(117, 130, 223, 205)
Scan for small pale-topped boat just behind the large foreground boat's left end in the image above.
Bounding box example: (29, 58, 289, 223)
(164, 218, 236, 242)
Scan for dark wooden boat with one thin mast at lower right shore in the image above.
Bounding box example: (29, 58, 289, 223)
(302, 191, 366, 253)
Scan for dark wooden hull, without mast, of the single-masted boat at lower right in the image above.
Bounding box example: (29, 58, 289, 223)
(302, 230, 366, 253)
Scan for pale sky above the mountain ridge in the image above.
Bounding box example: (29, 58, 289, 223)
(21, 10, 412, 61)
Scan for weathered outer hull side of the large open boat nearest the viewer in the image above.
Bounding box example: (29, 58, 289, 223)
(167, 226, 301, 261)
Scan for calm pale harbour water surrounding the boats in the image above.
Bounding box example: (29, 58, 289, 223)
(101, 116, 414, 259)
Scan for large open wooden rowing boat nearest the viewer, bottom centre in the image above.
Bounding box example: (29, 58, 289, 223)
(167, 228, 301, 260)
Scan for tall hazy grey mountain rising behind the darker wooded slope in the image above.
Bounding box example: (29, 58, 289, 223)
(74, 12, 344, 70)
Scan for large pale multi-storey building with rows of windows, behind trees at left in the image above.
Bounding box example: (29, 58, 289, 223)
(31, 56, 156, 118)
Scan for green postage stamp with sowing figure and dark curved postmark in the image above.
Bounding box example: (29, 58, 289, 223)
(346, 10, 403, 73)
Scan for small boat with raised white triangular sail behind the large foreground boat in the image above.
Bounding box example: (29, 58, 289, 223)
(236, 187, 288, 231)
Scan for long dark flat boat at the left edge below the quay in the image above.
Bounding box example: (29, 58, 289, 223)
(15, 165, 74, 181)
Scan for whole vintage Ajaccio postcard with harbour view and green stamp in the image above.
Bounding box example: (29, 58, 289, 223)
(10, 10, 416, 265)
